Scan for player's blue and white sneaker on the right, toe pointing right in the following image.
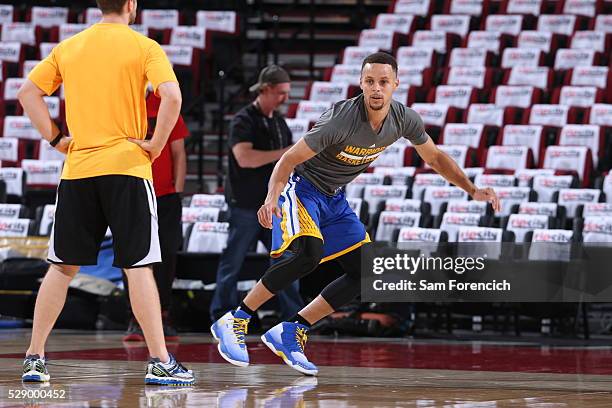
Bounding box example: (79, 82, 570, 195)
(261, 322, 319, 375)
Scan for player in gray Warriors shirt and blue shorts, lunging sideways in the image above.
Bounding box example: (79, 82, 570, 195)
(211, 52, 500, 375)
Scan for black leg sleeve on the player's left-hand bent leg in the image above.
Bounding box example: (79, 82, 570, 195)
(261, 236, 323, 293)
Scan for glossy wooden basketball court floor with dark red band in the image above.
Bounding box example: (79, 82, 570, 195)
(0, 329, 612, 408)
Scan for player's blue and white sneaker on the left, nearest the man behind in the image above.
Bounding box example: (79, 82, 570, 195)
(210, 309, 251, 367)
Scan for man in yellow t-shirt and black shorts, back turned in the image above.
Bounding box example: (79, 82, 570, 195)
(19, 0, 194, 385)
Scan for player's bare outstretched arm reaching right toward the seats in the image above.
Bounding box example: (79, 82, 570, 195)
(414, 137, 501, 211)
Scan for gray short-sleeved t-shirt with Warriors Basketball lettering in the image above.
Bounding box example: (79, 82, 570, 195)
(296, 95, 429, 195)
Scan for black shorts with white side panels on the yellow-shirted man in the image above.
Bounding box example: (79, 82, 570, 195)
(47, 175, 161, 268)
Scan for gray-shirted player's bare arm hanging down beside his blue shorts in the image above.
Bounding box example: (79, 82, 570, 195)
(257, 138, 317, 228)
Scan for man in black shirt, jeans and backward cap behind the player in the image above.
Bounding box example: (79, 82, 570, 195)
(210, 65, 303, 321)
